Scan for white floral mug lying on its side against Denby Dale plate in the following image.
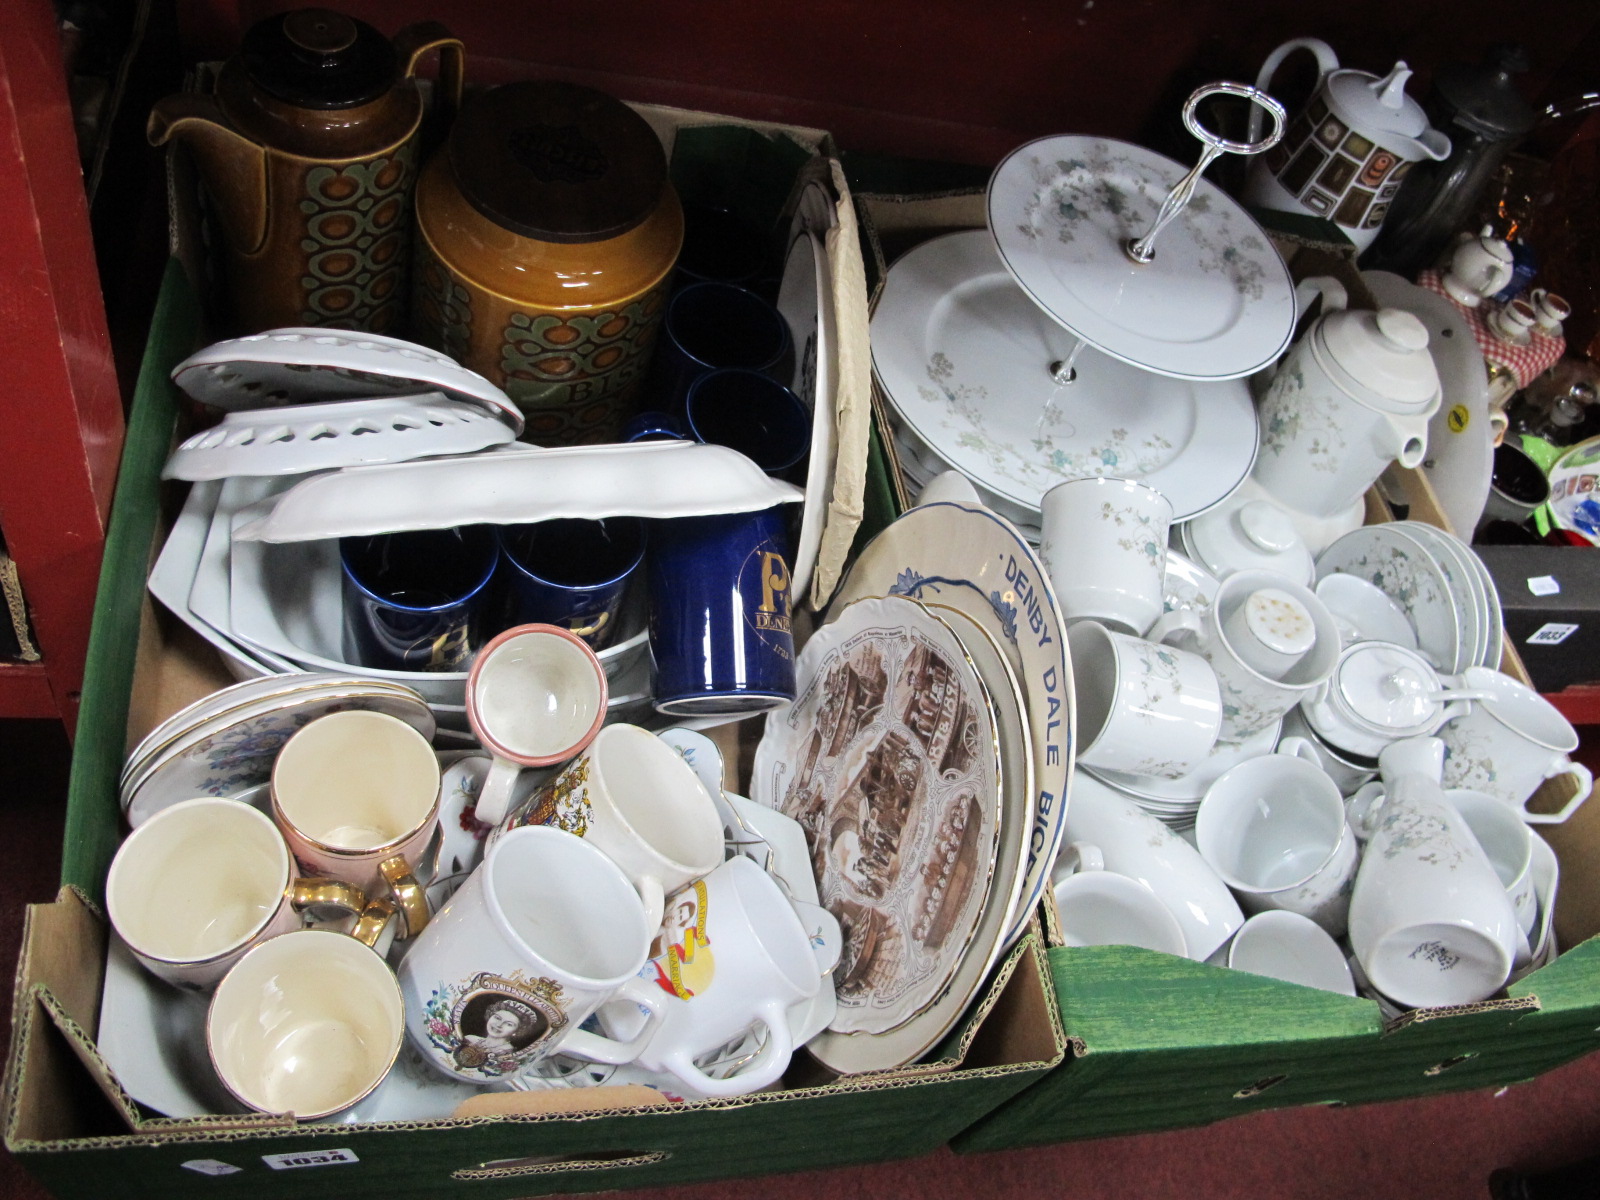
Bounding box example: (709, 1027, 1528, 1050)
(1067, 621, 1222, 779)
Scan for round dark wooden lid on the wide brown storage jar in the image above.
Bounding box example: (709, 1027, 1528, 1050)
(448, 80, 667, 242)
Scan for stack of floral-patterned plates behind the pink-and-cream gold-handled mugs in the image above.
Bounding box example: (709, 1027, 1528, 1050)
(122, 675, 434, 826)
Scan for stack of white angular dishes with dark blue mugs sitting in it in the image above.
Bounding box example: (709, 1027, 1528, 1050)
(149, 475, 650, 730)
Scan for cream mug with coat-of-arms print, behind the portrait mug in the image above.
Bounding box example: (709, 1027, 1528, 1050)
(490, 725, 723, 926)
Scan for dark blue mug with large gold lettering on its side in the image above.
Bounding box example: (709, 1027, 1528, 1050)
(648, 506, 795, 717)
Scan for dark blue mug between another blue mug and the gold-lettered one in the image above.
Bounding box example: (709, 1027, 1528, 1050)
(496, 517, 645, 650)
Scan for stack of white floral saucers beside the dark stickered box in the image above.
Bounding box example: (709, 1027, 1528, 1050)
(1317, 522, 1506, 675)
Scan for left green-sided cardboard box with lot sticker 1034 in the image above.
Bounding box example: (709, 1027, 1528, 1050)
(3, 110, 1064, 1200)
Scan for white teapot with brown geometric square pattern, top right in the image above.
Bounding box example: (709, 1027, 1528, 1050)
(1245, 37, 1450, 251)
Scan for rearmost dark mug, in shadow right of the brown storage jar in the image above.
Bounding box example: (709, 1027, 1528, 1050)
(648, 283, 790, 413)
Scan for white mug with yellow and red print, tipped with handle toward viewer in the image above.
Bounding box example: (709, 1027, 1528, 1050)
(637, 856, 822, 1096)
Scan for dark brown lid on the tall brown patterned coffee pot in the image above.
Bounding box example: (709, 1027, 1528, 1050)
(238, 8, 400, 109)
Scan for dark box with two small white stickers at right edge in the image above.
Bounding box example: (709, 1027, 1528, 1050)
(1474, 546, 1600, 691)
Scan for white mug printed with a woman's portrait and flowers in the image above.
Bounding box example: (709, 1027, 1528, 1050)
(398, 826, 666, 1085)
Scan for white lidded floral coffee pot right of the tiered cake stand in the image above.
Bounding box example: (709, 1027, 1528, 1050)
(1251, 277, 1440, 531)
